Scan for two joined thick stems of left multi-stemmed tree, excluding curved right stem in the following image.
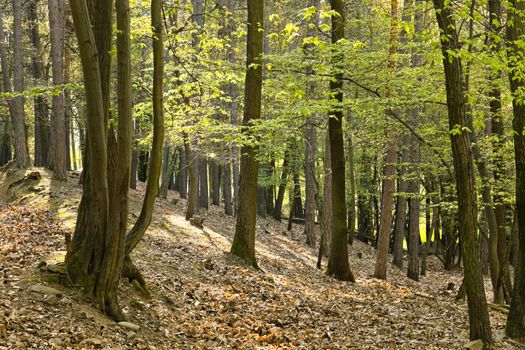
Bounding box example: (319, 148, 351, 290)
(66, 0, 131, 320)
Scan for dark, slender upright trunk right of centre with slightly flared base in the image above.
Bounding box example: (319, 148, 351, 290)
(327, 0, 355, 282)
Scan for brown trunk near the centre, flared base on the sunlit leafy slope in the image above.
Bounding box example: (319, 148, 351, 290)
(231, 0, 264, 266)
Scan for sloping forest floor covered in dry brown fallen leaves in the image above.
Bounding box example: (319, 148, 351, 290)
(0, 168, 525, 349)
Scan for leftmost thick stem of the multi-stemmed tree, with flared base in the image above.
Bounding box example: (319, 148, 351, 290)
(66, 0, 114, 319)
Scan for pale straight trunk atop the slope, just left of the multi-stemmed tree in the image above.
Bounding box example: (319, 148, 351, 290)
(48, 0, 68, 180)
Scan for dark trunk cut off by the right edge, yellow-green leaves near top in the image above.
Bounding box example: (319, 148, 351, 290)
(506, 0, 525, 339)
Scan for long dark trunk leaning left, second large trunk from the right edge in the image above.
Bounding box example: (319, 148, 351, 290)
(433, 0, 492, 344)
